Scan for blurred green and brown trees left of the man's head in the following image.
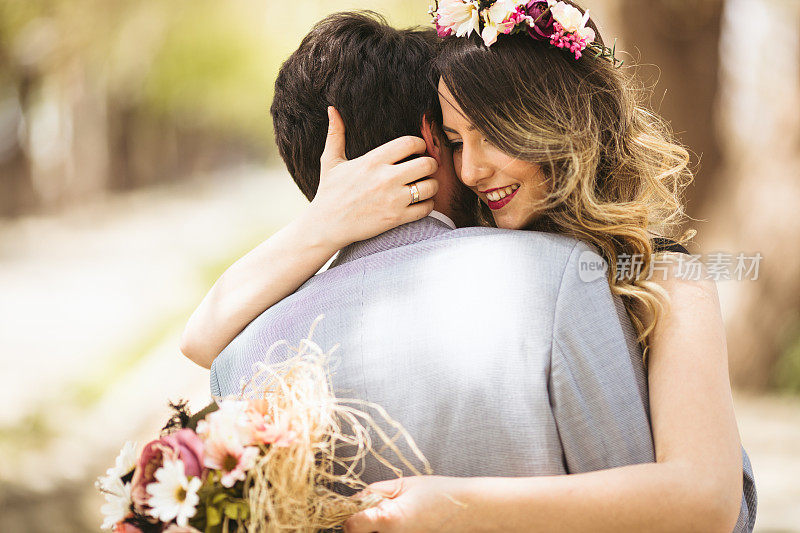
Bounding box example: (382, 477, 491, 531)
(0, 0, 424, 212)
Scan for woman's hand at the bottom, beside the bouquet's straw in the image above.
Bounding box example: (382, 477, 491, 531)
(344, 476, 478, 533)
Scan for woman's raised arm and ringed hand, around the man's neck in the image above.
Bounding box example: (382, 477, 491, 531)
(180, 108, 438, 368)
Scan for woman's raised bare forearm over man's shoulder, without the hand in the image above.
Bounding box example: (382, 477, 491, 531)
(181, 209, 342, 368)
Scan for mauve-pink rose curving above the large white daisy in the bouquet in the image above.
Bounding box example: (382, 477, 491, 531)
(131, 429, 206, 510)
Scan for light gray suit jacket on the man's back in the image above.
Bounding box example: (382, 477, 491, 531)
(211, 217, 756, 531)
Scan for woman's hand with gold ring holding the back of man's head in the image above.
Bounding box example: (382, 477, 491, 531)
(306, 107, 439, 248)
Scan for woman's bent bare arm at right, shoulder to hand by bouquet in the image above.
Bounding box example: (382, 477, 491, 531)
(347, 254, 742, 533)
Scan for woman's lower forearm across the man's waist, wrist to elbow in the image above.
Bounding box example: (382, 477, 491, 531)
(463, 463, 738, 533)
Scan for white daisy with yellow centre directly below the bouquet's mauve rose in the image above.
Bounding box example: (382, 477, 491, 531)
(147, 460, 203, 527)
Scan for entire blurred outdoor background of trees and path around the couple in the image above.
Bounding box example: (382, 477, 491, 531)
(0, 0, 800, 532)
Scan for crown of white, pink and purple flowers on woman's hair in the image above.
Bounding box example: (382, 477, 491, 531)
(428, 0, 623, 67)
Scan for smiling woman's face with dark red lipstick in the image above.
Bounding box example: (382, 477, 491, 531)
(439, 78, 546, 229)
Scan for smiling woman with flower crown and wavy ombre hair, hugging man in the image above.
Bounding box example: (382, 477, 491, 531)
(181, 0, 755, 533)
